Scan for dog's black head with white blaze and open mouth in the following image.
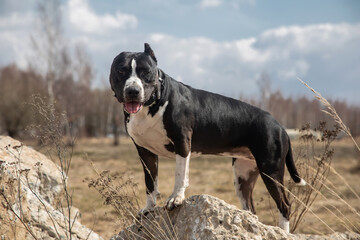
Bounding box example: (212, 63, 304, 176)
(110, 43, 161, 114)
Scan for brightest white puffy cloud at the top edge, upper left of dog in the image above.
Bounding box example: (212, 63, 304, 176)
(68, 0, 138, 33)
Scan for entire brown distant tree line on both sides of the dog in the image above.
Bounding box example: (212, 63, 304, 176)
(0, 64, 360, 142)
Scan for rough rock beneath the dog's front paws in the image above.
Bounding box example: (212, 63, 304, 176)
(112, 195, 360, 240)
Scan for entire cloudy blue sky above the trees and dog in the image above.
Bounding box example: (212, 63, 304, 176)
(0, 0, 360, 105)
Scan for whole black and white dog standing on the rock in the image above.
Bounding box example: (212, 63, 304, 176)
(110, 43, 305, 231)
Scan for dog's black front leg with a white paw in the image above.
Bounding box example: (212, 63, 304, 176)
(135, 144, 160, 214)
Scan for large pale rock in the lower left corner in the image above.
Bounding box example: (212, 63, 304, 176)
(0, 136, 102, 240)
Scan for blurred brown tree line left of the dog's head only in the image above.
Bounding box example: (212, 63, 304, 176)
(0, 64, 124, 143)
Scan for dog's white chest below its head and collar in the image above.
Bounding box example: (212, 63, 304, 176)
(126, 102, 175, 158)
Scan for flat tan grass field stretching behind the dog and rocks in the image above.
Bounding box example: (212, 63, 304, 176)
(30, 137, 360, 239)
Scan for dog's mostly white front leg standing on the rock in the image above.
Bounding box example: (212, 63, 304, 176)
(165, 152, 191, 210)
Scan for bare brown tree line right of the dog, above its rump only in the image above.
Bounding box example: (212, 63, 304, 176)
(245, 72, 360, 136)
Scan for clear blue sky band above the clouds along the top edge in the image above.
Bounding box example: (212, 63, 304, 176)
(89, 0, 360, 41)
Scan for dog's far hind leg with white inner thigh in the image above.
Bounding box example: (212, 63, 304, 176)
(232, 156, 259, 214)
